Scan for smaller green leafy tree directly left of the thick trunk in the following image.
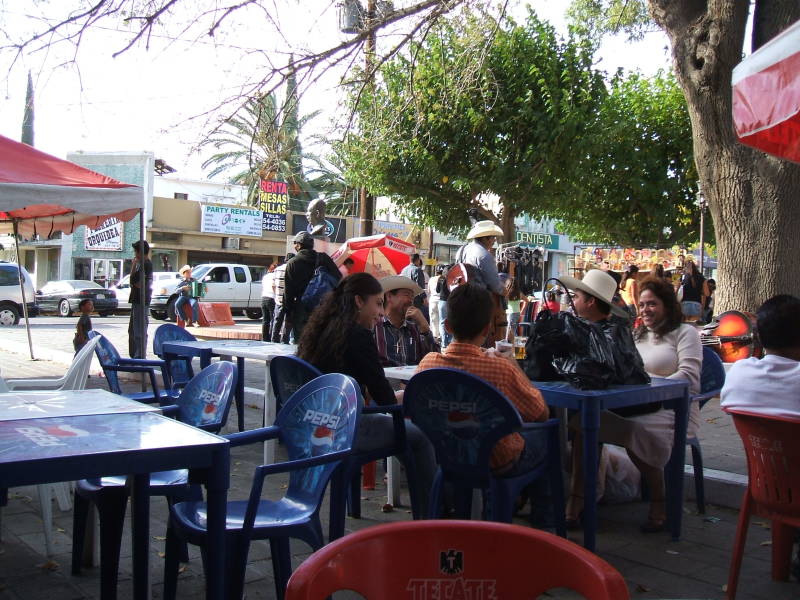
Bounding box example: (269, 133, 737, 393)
(552, 72, 709, 247)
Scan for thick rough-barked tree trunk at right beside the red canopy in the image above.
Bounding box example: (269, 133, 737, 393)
(649, 0, 800, 312)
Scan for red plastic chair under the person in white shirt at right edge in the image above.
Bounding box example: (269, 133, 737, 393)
(725, 408, 800, 600)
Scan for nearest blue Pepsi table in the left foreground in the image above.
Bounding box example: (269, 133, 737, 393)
(0, 410, 230, 600)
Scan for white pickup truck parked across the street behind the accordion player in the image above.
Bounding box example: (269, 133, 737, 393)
(150, 263, 261, 321)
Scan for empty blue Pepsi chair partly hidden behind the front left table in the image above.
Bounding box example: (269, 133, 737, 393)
(72, 361, 237, 599)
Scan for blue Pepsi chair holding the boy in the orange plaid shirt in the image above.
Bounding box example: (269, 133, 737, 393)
(403, 369, 566, 537)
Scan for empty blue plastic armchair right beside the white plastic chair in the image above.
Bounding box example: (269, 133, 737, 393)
(87, 331, 177, 404)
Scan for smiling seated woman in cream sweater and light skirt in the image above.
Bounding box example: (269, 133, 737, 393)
(567, 277, 703, 533)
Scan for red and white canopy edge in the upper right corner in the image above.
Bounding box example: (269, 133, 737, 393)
(731, 22, 800, 162)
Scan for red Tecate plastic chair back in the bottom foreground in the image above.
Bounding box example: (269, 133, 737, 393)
(286, 521, 629, 600)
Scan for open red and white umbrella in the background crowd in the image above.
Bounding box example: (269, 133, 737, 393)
(331, 234, 416, 279)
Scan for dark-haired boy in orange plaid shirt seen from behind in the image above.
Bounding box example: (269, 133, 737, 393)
(417, 283, 549, 522)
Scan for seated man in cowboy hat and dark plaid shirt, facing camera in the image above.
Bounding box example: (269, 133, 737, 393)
(374, 275, 439, 367)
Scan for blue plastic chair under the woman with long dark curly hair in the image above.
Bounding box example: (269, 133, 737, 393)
(270, 356, 420, 541)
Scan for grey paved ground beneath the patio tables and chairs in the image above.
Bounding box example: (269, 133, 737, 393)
(0, 323, 800, 600)
